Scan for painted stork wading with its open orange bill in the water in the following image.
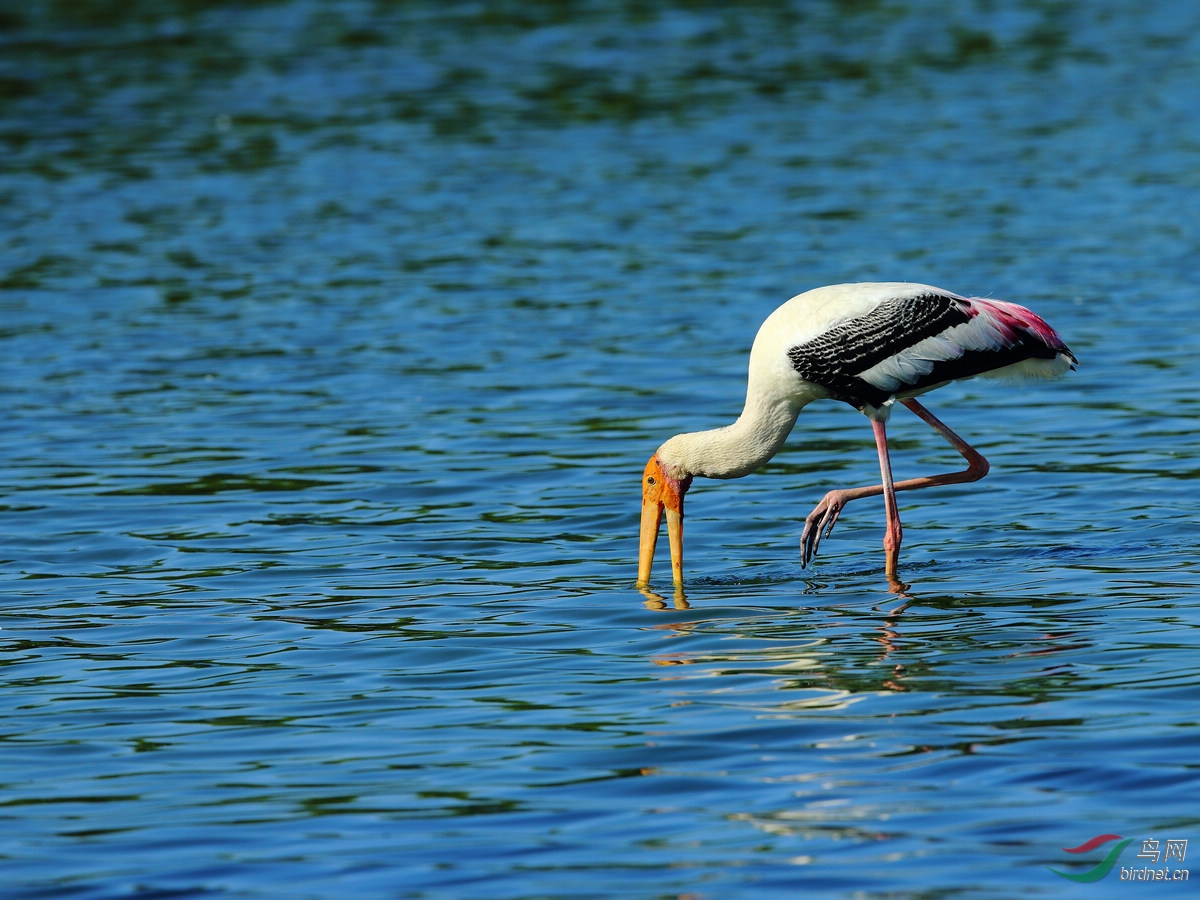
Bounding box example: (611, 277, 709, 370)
(637, 283, 1076, 587)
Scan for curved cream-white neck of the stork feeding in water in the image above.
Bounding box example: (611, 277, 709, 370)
(658, 391, 804, 487)
